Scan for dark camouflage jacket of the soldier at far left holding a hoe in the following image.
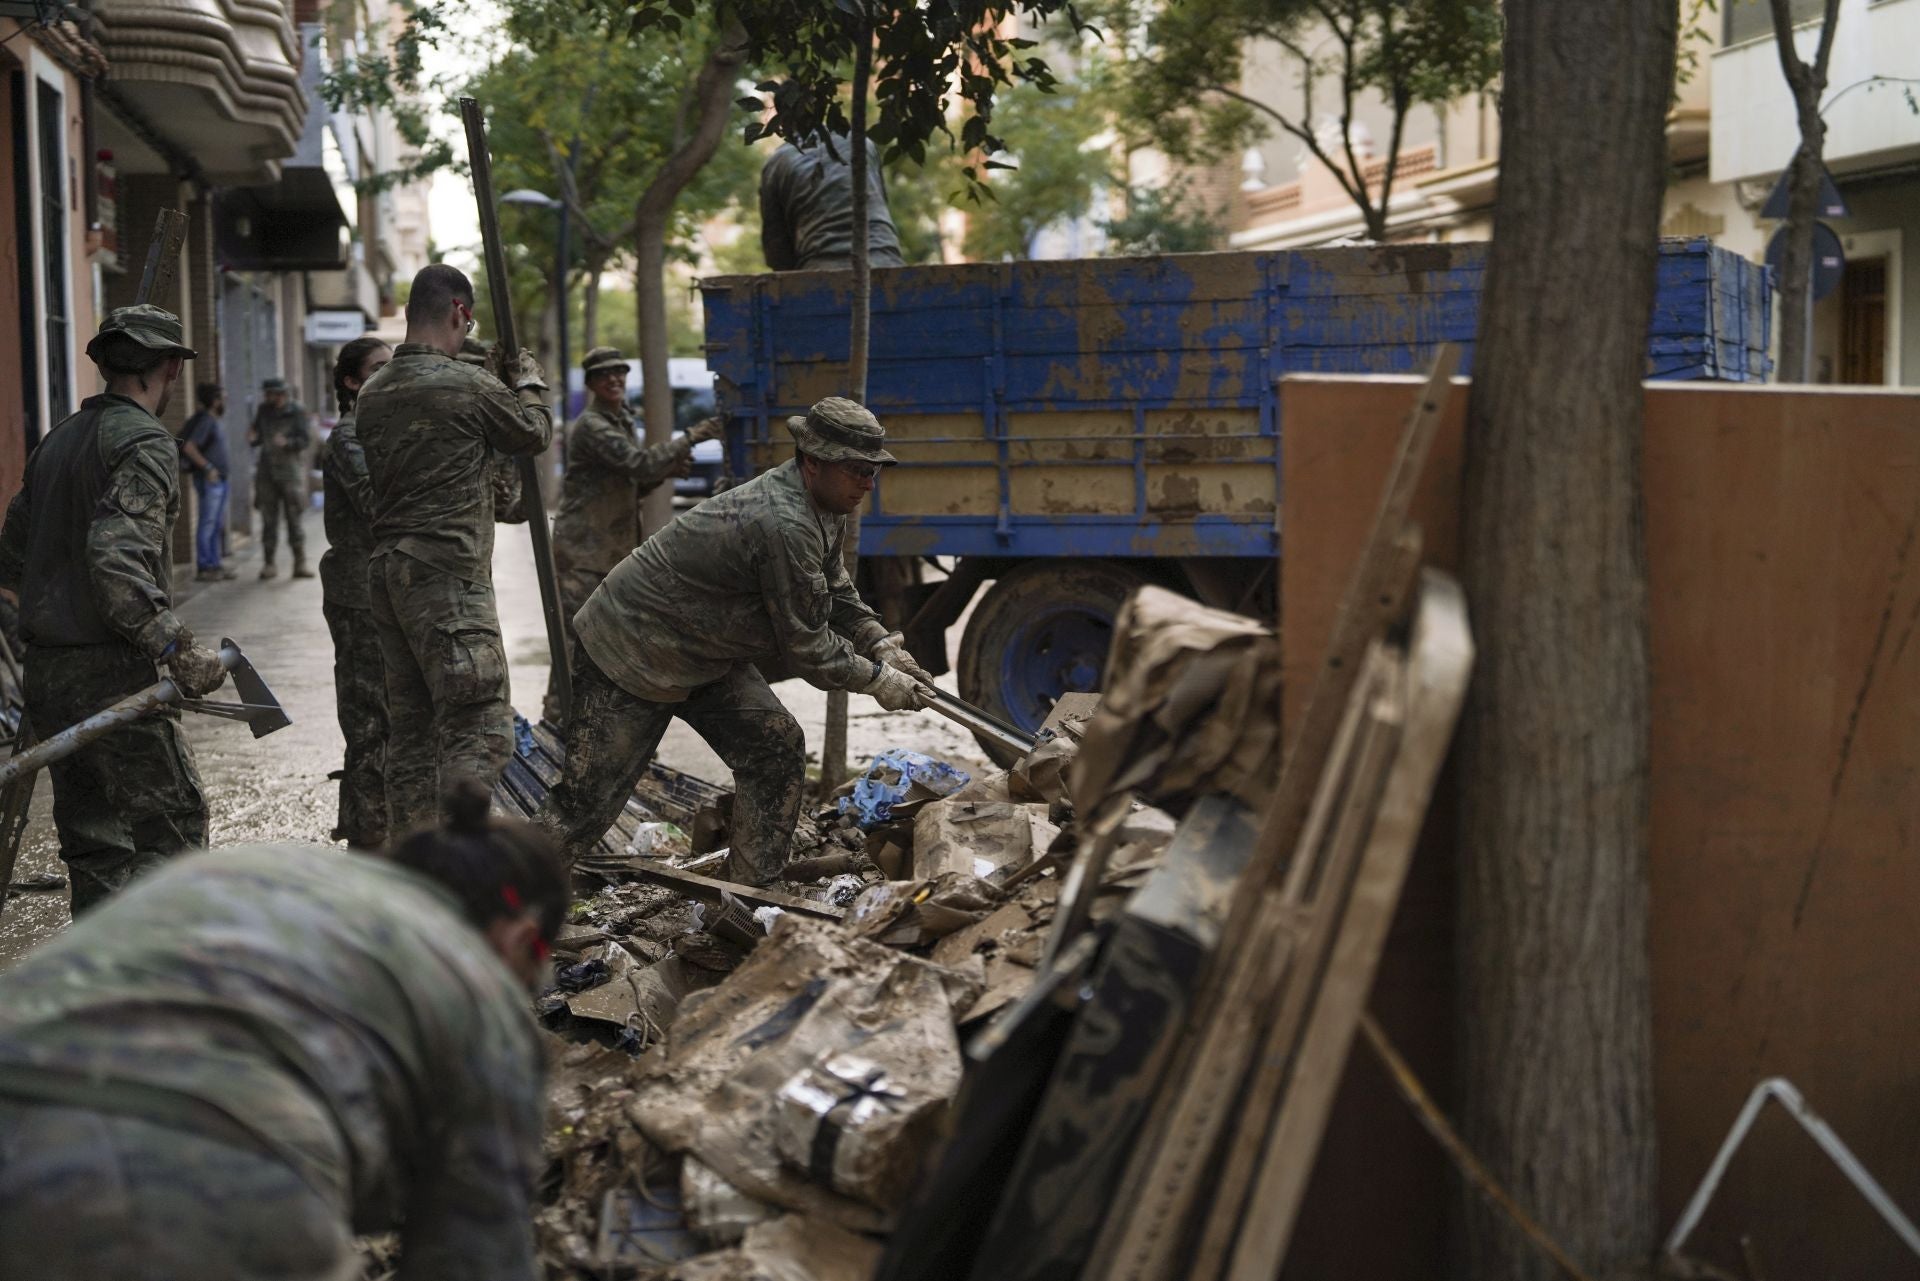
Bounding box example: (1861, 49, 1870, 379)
(0, 394, 182, 659)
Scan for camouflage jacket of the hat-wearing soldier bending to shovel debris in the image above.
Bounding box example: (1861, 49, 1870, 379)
(574, 459, 887, 703)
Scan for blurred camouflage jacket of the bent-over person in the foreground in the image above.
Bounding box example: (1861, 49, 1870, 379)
(0, 845, 543, 1281)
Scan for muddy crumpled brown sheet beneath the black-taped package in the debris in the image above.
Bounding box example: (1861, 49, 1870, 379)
(630, 914, 981, 1231)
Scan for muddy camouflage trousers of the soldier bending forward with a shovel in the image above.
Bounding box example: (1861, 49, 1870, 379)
(534, 645, 806, 885)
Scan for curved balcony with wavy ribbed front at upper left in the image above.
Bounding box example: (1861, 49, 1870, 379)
(92, 0, 307, 184)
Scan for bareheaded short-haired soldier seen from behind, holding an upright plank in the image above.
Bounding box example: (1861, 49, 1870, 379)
(353, 263, 553, 832)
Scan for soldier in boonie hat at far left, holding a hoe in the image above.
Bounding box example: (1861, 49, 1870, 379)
(0, 305, 227, 916)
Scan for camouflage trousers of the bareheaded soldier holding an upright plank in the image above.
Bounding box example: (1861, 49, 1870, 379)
(367, 551, 513, 837)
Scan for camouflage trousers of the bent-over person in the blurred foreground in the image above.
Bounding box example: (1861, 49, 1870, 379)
(0, 1099, 361, 1281)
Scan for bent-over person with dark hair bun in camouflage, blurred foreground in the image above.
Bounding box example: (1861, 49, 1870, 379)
(0, 789, 568, 1281)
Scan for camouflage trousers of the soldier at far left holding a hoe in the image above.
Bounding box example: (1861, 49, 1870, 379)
(22, 641, 207, 918)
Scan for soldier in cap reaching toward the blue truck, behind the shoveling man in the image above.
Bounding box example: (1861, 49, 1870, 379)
(545, 348, 720, 722)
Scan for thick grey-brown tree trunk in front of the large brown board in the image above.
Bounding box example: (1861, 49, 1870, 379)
(1457, 0, 1676, 1281)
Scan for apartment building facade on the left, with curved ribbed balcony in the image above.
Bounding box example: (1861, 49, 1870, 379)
(0, 0, 426, 559)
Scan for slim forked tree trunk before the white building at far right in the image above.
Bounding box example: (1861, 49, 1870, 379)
(1772, 0, 1839, 382)
